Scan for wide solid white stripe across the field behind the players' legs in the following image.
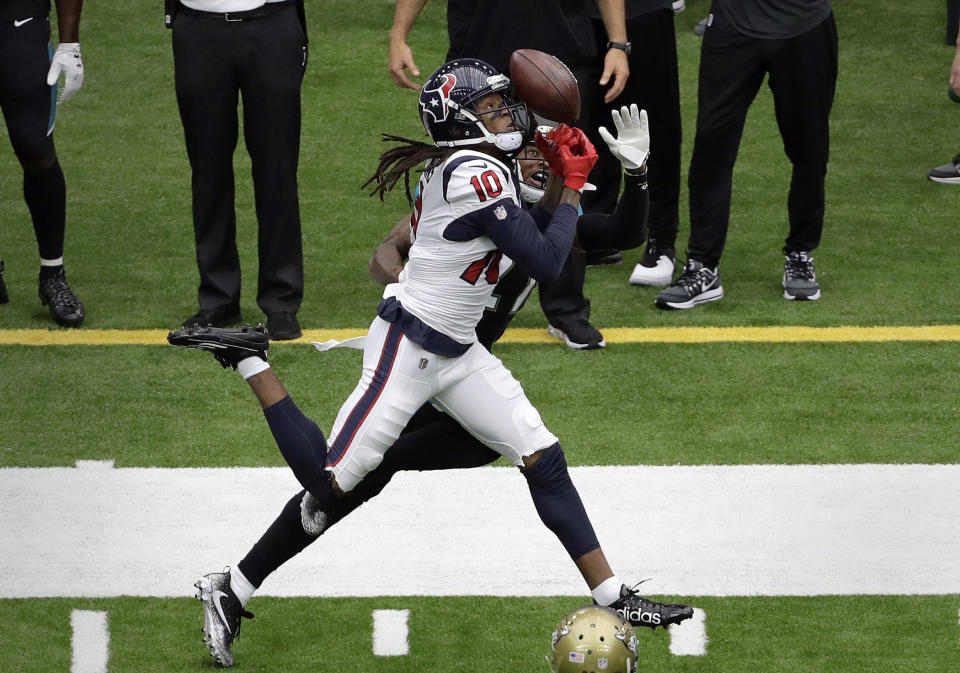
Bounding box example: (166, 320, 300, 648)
(0, 465, 960, 598)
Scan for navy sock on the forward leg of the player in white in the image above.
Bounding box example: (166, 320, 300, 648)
(521, 444, 600, 560)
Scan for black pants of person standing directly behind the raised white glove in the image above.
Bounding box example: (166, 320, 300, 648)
(583, 9, 682, 245)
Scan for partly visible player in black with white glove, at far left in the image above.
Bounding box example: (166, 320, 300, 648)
(0, 0, 86, 327)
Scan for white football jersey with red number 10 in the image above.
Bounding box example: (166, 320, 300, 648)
(396, 149, 521, 343)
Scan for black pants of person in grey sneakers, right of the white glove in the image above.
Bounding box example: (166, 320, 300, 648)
(687, 13, 837, 267)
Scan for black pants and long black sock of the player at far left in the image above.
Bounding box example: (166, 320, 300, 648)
(0, 16, 67, 259)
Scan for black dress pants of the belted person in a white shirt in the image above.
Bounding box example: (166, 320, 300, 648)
(173, 2, 307, 314)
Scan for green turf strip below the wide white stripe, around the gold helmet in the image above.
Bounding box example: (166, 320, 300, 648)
(0, 596, 960, 673)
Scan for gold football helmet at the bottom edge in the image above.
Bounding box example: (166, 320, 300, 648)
(548, 605, 637, 673)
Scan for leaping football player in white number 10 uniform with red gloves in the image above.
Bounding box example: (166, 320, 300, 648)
(169, 59, 692, 665)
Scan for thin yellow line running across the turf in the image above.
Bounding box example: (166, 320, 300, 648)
(0, 325, 960, 346)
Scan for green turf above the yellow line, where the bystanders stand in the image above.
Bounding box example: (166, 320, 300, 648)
(0, 0, 960, 328)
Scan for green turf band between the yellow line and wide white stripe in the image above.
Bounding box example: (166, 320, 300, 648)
(0, 343, 960, 467)
